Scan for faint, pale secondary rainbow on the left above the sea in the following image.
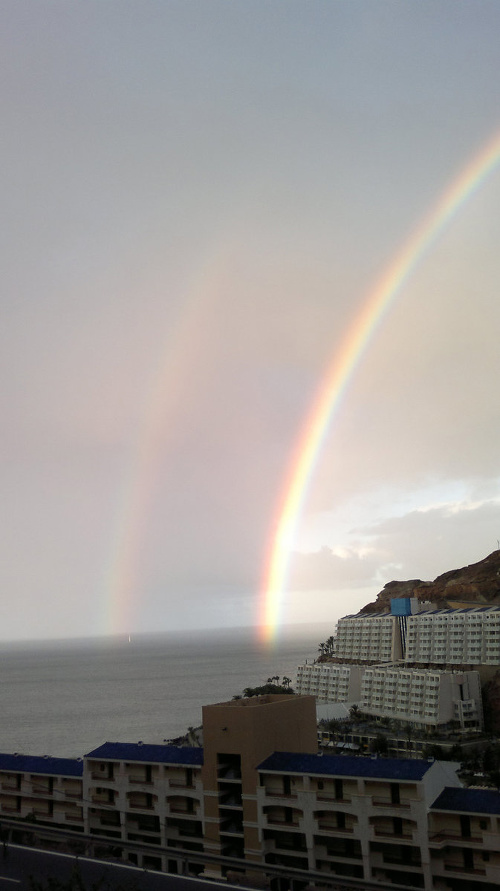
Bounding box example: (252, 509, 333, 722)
(101, 244, 237, 635)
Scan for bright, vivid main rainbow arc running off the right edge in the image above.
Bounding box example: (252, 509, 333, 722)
(258, 127, 500, 642)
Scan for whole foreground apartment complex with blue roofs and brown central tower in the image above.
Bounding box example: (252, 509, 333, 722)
(0, 695, 500, 891)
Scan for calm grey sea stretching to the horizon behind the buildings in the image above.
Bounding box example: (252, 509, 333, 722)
(0, 625, 331, 758)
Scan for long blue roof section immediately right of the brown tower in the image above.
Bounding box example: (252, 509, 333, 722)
(258, 752, 432, 780)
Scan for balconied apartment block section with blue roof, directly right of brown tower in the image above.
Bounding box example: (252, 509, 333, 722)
(258, 752, 460, 888)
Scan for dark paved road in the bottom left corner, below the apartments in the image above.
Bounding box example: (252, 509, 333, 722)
(0, 845, 229, 891)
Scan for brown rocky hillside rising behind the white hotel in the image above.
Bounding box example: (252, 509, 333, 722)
(361, 550, 500, 613)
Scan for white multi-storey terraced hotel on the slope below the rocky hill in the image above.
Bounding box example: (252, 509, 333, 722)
(296, 599, 500, 730)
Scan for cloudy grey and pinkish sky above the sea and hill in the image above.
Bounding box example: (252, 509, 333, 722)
(0, 0, 500, 640)
